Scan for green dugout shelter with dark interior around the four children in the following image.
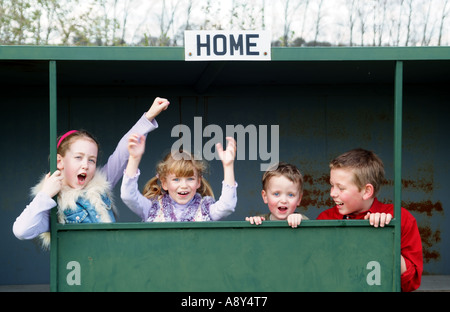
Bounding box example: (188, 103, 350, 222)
(0, 46, 450, 291)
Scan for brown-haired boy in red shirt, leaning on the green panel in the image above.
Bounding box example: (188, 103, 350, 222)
(317, 149, 423, 291)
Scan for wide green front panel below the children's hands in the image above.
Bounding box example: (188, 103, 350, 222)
(54, 221, 395, 292)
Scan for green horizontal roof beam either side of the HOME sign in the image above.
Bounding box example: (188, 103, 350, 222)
(0, 46, 450, 61)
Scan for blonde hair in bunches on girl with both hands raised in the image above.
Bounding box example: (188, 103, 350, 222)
(142, 151, 214, 198)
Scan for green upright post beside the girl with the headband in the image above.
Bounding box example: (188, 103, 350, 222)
(49, 61, 58, 291)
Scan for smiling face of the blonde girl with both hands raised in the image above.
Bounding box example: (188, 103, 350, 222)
(161, 172, 201, 205)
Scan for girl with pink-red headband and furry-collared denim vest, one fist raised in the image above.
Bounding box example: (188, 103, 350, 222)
(13, 98, 169, 248)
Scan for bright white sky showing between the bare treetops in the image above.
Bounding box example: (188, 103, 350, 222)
(119, 0, 450, 45)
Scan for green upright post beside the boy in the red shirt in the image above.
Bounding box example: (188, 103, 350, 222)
(394, 61, 403, 291)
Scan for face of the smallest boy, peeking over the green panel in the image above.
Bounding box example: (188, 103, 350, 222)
(261, 176, 302, 220)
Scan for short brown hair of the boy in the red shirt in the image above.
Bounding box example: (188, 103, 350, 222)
(330, 148, 385, 196)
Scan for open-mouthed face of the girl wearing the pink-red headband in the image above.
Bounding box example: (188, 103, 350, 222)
(57, 139, 98, 189)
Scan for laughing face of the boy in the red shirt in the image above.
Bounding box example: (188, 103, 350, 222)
(330, 168, 370, 215)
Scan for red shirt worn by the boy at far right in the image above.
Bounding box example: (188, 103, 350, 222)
(317, 198, 423, 291)
